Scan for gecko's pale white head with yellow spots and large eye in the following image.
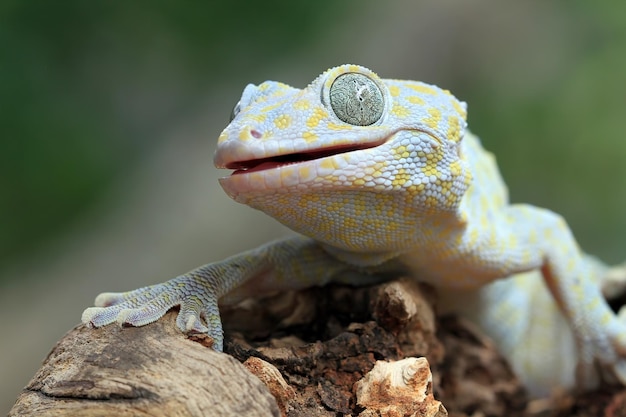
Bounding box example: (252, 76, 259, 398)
(214, 65, 470, 251)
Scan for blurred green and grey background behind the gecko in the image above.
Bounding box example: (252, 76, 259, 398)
(0, 0, 626, 413)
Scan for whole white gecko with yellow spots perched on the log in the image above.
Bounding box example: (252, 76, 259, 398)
(82, 65, 626, 396)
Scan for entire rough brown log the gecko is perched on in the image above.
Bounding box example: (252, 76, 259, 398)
(10, 279, 626, 417)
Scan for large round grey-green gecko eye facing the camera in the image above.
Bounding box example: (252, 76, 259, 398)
(329, 72, 384, 126)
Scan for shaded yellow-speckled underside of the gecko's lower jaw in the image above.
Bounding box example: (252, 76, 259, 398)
(220, 175, 421, 250)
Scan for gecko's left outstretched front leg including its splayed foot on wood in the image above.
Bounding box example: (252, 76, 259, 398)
(82, 237, 349, 351)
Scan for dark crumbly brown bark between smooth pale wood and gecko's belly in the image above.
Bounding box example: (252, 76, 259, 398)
(224, 279, 526, 416)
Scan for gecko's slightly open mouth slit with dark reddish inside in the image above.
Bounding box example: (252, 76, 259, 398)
(226, 141, 384, 175)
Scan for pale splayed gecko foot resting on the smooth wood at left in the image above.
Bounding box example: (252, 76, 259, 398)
(82, 275, 224, 351)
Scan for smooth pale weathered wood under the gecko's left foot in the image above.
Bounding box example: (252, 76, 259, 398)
(9, 312, 280, 417)
